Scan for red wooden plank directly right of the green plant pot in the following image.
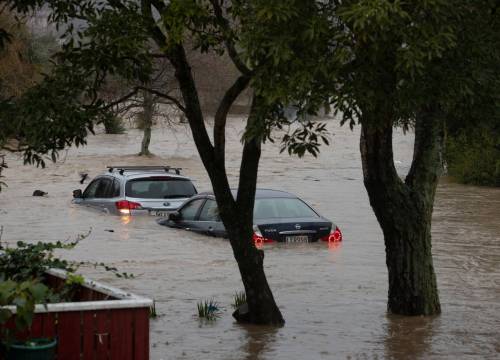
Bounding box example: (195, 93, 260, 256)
(57, 311, 81, 360)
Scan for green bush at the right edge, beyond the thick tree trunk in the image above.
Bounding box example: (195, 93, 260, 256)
(445, 126, 500, 186)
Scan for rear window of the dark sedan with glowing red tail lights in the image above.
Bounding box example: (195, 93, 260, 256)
(253, 198, 319, 219)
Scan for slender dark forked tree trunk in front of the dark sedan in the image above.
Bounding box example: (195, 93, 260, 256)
(165, 45, 284, 326)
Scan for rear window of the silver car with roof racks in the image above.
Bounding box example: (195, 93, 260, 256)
(125, 177, 196, 199)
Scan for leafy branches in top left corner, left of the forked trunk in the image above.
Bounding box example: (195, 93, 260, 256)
(0, 1, 151, 166)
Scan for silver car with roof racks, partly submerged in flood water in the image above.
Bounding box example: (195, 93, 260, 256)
(73, 166, 197, 216)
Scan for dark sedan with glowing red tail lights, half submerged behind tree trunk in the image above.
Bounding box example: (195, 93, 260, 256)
(158, 189, 342, 243)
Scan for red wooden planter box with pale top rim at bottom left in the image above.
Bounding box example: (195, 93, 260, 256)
(0, 270, 152, 360)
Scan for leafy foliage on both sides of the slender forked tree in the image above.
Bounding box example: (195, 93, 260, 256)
(0, 0, 332, 166)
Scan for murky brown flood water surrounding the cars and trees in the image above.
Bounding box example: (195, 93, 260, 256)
(0, 119, 500, 360)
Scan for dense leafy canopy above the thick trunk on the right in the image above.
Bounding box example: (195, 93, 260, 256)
(319, 0, 499, 126)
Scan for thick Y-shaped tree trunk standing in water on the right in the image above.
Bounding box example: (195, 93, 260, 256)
(360, 107, 443, 315)
